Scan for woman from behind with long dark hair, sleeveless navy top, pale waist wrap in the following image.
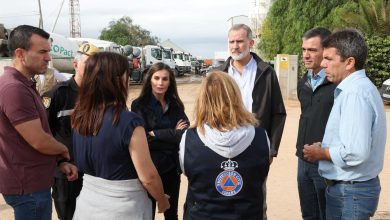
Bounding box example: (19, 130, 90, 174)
(71, 52, 169, 220)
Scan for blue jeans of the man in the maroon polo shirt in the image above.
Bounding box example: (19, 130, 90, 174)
(3, 188, 52, 220)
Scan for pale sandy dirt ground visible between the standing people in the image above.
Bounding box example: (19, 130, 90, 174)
(0, 77, 390, 220)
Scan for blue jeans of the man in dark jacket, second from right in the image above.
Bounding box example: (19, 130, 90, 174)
(297, 159, 326, 220)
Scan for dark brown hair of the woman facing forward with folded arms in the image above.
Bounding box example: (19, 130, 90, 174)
(138, 62, 184, 110)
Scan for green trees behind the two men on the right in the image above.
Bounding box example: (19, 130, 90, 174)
(257, 0, 390, 86)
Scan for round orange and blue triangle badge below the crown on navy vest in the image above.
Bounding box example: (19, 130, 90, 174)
(215, 170, 244, 196)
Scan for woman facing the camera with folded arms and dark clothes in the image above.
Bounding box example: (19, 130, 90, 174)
(131, 63, 188, 220)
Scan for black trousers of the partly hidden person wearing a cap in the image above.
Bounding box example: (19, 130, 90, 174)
(52, 177, 83, 220)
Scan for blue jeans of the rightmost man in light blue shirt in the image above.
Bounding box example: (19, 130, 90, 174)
(326, 177, 381, 220)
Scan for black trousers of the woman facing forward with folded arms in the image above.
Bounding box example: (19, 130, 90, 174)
(149, 169, 180, 220)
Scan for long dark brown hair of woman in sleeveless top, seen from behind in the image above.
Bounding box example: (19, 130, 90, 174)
(72, 52, 129, 136)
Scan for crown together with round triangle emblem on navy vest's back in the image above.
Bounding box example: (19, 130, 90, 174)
(215, 159, 244, 196)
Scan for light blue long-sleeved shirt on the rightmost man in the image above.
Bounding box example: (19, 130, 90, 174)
(319, 70, 387, 181)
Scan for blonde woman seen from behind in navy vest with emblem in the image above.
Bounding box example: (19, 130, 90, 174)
(179, 71, 270, 220)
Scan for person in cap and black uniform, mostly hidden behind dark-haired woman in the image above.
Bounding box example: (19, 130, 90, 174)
(42, 43, 99, 220)
